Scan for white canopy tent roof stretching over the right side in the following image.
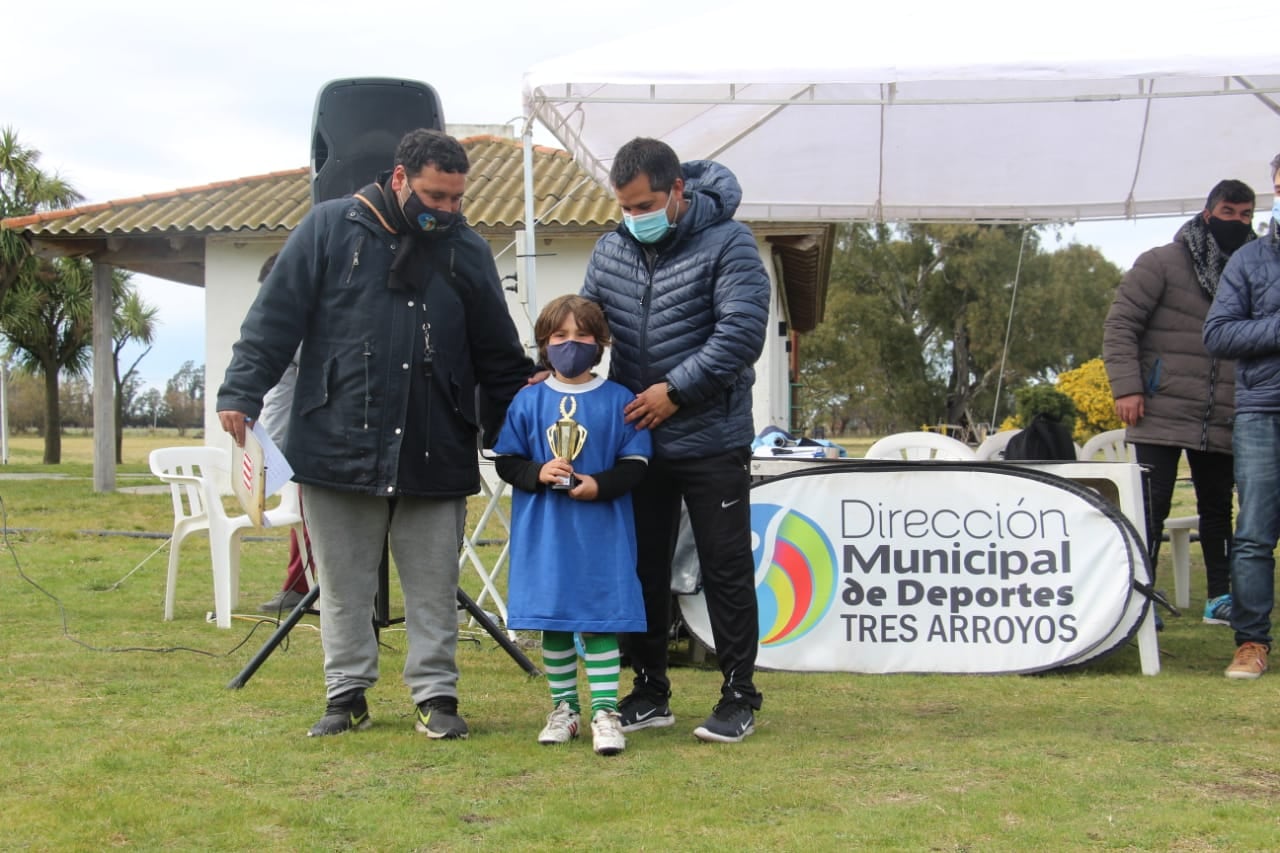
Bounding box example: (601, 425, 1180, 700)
(524, 0, 1280, 222)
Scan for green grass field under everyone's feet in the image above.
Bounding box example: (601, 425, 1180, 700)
(0, 435, 1280, 852)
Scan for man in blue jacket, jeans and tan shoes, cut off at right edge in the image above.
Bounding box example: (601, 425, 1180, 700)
(1204, 156, 1280, 679)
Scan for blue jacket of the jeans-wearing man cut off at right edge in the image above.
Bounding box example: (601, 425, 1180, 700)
(1204, 222, 1280, 415)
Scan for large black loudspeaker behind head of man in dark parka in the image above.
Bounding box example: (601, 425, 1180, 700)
(311, 77, 444, 204)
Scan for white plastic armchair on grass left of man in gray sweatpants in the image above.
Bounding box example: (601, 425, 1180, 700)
(150, 447, 311, 628)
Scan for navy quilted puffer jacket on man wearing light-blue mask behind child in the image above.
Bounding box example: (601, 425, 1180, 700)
(582, 160, 771, 459)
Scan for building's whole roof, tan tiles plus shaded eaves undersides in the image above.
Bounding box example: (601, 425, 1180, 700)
(0, 136, 835, 326)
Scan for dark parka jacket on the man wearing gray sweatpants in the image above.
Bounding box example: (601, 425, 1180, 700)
(218, 184, 534, 497)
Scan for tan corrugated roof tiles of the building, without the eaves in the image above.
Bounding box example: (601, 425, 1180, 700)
(3, 136, 618, 238)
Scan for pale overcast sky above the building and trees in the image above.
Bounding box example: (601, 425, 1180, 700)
(0, 0, 1239, 388)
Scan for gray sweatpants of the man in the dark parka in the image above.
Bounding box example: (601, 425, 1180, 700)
(302, 485, 467, 704)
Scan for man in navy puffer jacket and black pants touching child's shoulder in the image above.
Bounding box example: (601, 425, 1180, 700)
(582, 138, 771, 743)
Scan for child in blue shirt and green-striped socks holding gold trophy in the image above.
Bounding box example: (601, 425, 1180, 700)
(494, 296, 652, 756)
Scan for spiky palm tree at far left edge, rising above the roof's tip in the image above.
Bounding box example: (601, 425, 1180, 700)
(0, 127, 83, 304)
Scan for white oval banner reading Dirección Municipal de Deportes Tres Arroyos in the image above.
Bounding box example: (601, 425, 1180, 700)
(680, 462, 1148, 674)
